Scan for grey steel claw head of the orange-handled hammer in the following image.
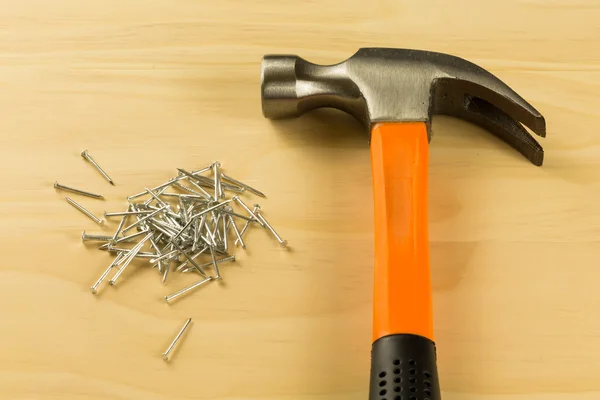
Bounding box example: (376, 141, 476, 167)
(261, 48, 546, 165)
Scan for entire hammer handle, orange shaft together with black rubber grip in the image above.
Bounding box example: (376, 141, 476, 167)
(369, 122, 441, 400)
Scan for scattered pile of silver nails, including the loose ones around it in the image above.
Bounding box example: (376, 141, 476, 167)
(54, 155, 287, 359)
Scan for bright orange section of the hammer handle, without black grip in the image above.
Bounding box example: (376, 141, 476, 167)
(371, 122, 433, 341)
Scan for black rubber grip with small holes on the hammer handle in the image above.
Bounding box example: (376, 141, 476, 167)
(369, 335, 442, 400)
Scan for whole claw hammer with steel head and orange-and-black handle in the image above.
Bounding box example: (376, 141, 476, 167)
(261, 48, 546, 400)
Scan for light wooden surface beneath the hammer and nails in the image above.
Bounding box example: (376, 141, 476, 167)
(0, 0, 600, 400)
